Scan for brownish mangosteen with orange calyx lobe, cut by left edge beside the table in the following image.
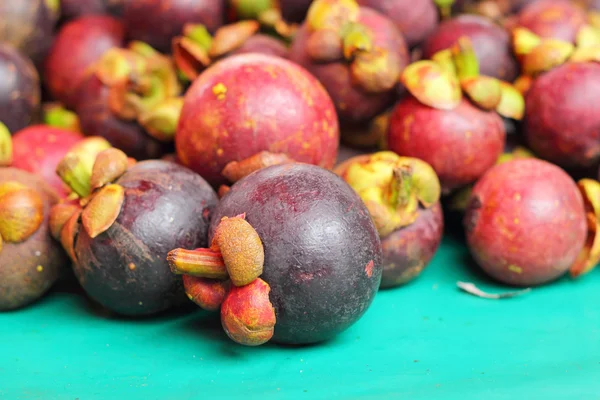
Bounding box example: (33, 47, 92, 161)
(0, 167, 68, 311)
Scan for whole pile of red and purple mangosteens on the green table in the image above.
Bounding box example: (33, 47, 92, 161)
(0, 0, 600, 346)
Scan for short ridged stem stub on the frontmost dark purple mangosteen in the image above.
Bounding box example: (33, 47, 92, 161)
(167, 249, 229, 279)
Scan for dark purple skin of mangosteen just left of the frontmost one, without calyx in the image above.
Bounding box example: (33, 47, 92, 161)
(74, 161, 217, 316)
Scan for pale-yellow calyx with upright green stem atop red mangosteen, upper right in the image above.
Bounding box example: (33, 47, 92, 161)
(401, 37, 525, 120)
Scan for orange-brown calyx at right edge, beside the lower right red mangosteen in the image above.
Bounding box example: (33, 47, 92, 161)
(571, 179, 600, 277)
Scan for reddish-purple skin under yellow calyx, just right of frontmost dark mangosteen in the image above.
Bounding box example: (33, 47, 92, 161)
(381, 202, 444, 288)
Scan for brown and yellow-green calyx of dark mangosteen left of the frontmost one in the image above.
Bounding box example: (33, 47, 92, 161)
(49, 147, 133, 261)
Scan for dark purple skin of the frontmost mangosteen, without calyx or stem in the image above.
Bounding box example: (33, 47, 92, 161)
(209, 164, 382, 344)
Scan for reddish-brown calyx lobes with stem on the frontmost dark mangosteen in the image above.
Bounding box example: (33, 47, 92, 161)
(167, 214, 275, 346)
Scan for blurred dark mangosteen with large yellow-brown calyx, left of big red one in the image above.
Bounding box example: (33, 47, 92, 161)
(75, 42, 183, 160)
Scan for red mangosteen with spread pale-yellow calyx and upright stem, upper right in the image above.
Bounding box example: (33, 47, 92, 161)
(387, 38, 524, 193)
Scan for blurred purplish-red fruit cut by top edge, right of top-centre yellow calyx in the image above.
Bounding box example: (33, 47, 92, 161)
(358, 0, 438, 47)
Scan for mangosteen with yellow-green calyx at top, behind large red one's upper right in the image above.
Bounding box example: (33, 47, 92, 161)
(290, 0, 409, 125)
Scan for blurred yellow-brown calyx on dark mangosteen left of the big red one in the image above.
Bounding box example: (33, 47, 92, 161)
(94, 41, 183, 142)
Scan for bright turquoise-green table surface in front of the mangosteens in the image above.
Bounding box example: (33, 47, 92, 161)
(0, 237, 600, 400)
